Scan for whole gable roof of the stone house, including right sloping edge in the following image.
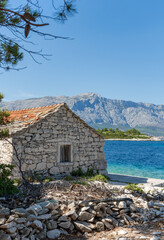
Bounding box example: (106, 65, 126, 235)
(6, 103, 104, 139)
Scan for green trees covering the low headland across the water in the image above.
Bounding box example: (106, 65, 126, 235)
(97, 128, 150, 139)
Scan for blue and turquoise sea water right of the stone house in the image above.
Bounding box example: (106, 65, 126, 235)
(104, 140, 164, 179)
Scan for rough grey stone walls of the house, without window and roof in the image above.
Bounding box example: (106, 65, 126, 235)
(0, 106, 107, 175)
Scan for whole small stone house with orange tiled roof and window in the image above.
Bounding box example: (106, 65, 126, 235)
(0, 103, 107, 175)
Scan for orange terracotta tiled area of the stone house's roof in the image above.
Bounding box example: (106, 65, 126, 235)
(9, 103, 64, 125)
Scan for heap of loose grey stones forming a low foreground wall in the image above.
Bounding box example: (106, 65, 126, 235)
(0, 194, 164, 240)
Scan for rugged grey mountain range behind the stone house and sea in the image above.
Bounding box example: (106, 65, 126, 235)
(1, 93, 164, 136)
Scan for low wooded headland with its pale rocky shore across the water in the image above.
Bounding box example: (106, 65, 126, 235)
(96, 128, 161, 141)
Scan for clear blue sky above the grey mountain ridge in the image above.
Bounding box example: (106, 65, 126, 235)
(0, 0, 164, 104)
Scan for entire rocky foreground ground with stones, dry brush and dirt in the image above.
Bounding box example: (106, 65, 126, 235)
(0, 180, 164, 240)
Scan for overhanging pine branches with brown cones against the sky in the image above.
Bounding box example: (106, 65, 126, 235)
(0, 0, 76, 70)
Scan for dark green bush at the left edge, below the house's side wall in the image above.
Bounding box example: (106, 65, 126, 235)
(0, 164, 18, 197)
